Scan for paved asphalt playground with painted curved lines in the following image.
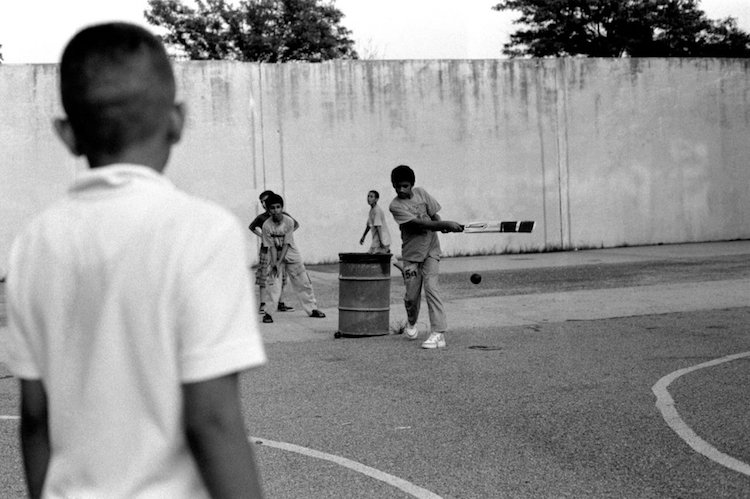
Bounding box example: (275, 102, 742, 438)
(0, 241, 750, 498)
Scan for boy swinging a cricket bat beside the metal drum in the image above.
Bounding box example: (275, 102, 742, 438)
(390, 165, 464, 349)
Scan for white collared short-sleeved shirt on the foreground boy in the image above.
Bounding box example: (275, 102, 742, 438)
(7, 165, 265, 498)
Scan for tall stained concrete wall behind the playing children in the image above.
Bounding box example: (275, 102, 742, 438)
(0, 59, 750, 270)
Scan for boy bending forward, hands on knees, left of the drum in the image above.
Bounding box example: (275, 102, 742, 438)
(263, 194, 325, 323)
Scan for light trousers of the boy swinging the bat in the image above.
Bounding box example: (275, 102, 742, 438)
(404, 256, 448, 333)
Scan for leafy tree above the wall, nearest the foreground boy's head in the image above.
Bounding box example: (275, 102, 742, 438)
(144, 0, 357, 62)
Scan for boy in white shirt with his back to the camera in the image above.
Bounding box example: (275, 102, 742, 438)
(7, 23, 265, 498)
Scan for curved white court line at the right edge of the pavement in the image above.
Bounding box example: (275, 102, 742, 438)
(651, 352, 750, 476)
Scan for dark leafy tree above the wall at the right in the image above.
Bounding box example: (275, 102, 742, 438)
(492, 0, 750, 57)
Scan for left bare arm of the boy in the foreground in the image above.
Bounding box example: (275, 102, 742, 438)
(21, 379, 50, 499)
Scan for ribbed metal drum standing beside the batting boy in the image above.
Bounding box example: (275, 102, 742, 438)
(336, 253, 393, 337)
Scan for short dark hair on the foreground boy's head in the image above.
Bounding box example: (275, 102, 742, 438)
(60, 23, 175, 154)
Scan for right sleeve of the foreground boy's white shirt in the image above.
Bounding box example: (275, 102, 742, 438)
(178, 215, 266, 383)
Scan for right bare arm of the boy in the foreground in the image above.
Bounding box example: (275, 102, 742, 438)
(182, 373, 262, 498)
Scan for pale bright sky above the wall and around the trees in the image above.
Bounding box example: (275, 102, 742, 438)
(0, 0, 750, 64)
